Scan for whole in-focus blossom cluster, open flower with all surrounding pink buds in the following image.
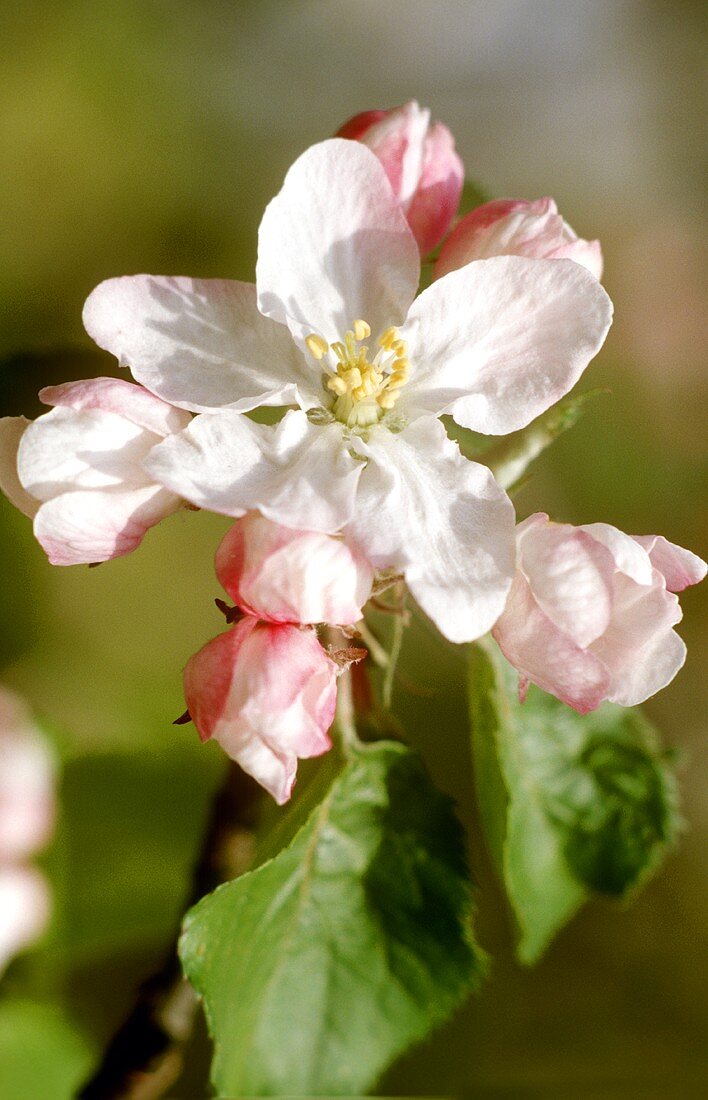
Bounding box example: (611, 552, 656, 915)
(0, 102, 706, 802)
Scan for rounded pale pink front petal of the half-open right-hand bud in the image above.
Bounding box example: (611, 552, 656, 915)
(517, 523, 615, 648)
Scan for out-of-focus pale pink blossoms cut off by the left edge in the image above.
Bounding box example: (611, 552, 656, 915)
(0, 688, 56, 972)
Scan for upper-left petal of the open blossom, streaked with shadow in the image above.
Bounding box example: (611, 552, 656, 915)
(84, 275, 320, 413)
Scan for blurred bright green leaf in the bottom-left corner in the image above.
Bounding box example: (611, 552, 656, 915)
(0, 1000, 93, 1100)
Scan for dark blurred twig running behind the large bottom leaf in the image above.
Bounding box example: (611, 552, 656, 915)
(77, 765, 261, 1100)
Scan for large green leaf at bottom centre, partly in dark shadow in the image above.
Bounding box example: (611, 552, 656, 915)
(180, 741, 484, 1096)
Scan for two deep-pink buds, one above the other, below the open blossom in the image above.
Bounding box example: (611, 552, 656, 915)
(184, 513, 373, 803)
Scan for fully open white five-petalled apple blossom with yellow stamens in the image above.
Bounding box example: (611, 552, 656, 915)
(84, 139, 611, 641)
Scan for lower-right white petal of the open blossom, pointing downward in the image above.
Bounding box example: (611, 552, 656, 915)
(350, 418, 515, 642)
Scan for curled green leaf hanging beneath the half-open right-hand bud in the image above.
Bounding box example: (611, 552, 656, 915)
(469, 642, 679, 964)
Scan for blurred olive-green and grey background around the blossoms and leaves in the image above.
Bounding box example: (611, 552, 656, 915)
(0, 0, 708, 1100)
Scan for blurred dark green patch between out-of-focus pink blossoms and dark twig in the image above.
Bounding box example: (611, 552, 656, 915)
(41, 745, 223, 976)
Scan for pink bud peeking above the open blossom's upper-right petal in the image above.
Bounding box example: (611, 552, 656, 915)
(434, 198, 602, 279)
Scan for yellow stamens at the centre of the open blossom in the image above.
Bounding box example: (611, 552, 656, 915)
(305, 320, 410, 428)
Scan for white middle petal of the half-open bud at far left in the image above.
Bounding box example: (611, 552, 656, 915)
(18, 408, 161, 501)
